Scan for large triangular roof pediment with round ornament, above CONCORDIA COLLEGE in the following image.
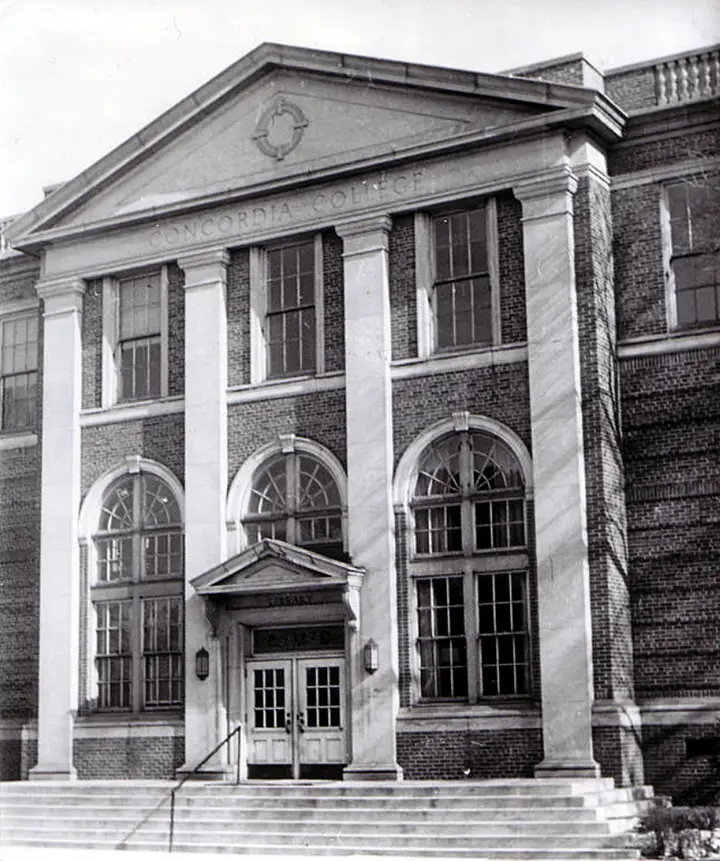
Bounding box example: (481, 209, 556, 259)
(8, 45, 624, 248)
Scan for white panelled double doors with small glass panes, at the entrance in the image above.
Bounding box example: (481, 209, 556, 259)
(246, 654, 347, 780)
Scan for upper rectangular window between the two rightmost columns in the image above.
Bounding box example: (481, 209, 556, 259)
(433, 207, 493, 350)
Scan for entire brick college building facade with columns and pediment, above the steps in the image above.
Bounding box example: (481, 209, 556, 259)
(0, 45, 720, 800)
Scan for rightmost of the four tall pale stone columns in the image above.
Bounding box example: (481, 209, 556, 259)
(514, 170, 599, 777)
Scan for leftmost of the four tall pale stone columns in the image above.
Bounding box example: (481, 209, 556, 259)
(30, 278, 85, 780)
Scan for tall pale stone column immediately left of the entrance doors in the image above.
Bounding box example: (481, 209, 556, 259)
(178, 249, 229, 777)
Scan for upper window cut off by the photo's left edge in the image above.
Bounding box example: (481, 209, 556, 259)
(0, 314, 38, 431)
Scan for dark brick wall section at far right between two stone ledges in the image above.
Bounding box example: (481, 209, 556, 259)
(621, 348, 720, 696)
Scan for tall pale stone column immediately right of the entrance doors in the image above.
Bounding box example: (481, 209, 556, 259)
(335, 216, 402, 780)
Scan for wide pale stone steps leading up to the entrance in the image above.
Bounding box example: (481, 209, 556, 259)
(0, 780, 652, 861)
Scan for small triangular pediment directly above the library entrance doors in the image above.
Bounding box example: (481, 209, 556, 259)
(192, 538, 363, 597)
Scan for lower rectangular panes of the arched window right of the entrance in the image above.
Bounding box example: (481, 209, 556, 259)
(415, 571, 529, 700)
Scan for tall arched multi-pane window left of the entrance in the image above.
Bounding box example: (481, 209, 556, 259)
(91, 469, 183, 712)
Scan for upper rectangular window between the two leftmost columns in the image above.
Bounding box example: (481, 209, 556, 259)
(116, 272, 163, 401)
